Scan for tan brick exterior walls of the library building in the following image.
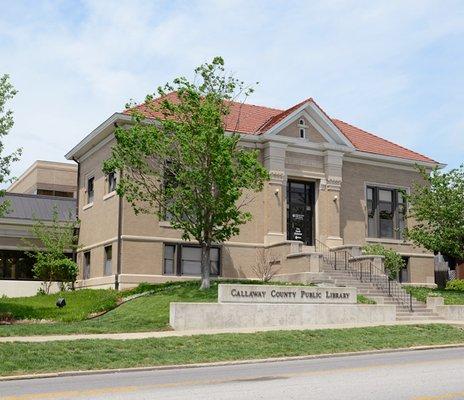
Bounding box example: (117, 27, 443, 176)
(78, 122, 433, 282)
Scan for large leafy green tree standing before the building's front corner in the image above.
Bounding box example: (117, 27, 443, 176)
(103, 57, 268, 289)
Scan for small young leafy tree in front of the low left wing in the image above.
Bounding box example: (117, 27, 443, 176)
(24, 207, 79, 293)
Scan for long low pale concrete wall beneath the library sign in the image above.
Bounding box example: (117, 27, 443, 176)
(169, 303, 396, 330)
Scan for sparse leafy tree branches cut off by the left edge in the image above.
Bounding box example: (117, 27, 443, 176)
(0, 74, 21, 217)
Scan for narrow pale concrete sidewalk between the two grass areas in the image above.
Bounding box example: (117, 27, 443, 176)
(0, 320, 464, 343)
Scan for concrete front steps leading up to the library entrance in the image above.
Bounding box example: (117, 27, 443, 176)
(322, 262, 443, 321)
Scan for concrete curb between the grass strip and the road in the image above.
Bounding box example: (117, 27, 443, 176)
(0, 343, 464, 382)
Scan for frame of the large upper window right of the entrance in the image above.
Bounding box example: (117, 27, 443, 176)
(364, 183, 409, 240)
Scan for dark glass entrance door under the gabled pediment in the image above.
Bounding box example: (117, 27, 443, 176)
(287, 181, 314, 246)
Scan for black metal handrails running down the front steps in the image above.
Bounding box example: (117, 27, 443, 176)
(315, 239, 413, 311)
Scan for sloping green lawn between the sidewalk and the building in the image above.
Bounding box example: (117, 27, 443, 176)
(0, 281, 371, 336)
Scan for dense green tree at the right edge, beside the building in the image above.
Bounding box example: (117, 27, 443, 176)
(405, 165, 464, 261)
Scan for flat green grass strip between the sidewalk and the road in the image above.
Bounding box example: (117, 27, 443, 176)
(0, 325, 464, 375)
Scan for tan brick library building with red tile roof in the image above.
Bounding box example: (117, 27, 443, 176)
(66, 95, 438, 288)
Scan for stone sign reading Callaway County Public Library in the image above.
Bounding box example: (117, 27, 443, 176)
(218, 284, 357, 304)
